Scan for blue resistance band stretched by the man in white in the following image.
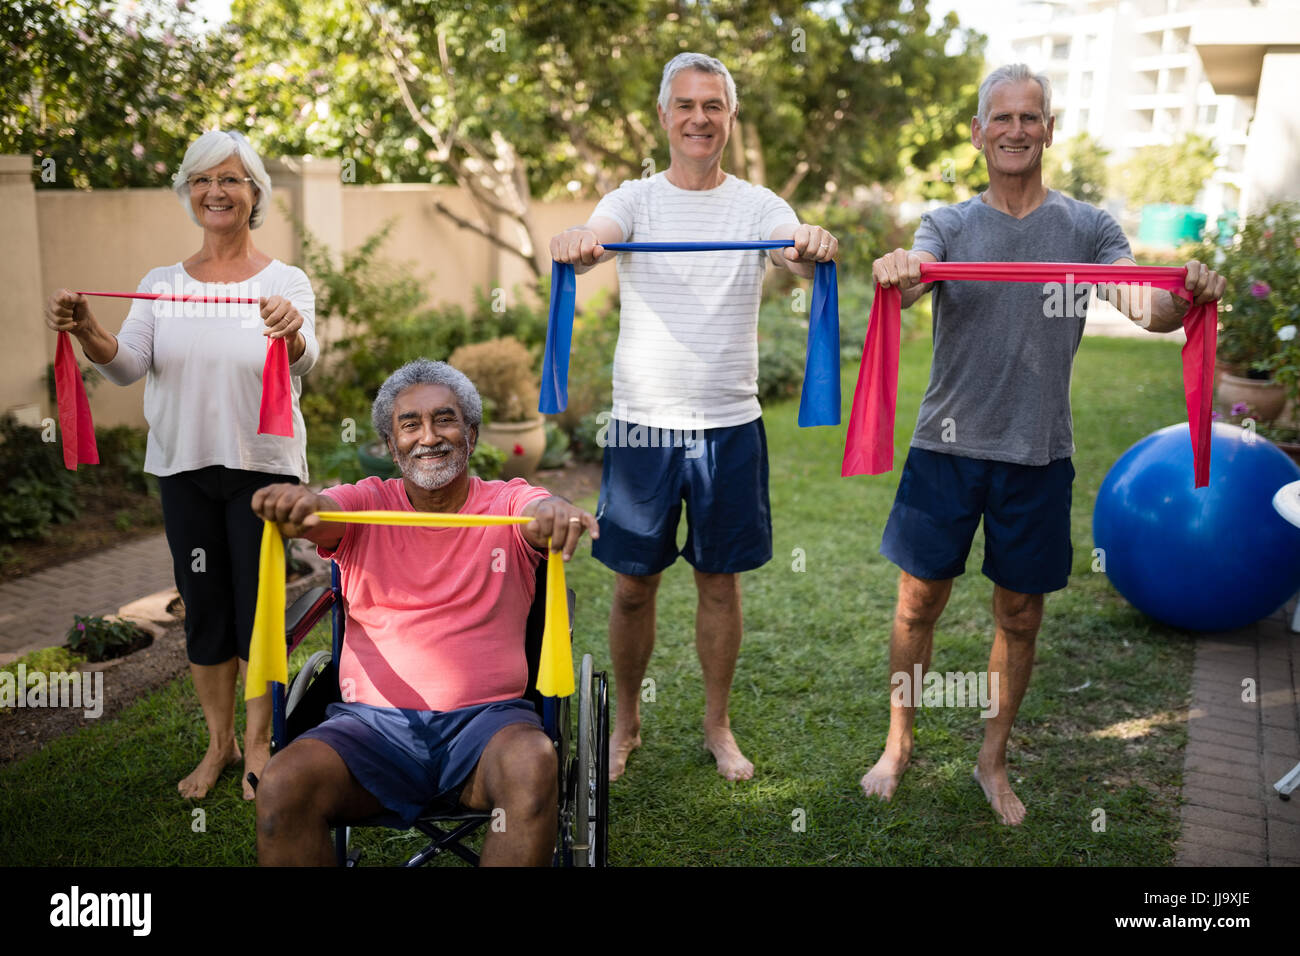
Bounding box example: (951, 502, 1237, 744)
(538, 239, 840, 428)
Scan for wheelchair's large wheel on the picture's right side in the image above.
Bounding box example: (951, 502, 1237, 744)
(573, 654, 610, 866)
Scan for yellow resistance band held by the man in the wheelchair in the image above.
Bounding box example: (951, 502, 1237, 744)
(244, 511, 573, 701)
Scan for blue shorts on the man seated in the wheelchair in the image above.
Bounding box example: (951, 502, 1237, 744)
(298, 700, 542, 827)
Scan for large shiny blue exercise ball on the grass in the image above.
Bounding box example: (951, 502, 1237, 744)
(1092, 423, 1300, 631)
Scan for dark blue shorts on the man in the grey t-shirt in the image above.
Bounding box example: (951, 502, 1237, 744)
(880, 447, 1074, 594)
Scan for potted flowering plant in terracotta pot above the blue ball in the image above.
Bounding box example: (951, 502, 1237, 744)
(1209, 202, 1300, 421)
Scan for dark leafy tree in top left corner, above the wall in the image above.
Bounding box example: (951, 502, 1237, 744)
(0, 0, 231, 189)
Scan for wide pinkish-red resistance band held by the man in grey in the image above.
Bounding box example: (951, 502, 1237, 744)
(840, 263, 1218, 488)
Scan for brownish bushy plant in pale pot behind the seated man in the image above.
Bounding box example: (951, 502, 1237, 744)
(447, 336, 546, 479)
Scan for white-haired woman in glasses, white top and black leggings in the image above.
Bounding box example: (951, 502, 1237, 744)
(46, 131, 320, 800)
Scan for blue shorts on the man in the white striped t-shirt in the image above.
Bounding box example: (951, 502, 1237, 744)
(592, 419, 772, 575)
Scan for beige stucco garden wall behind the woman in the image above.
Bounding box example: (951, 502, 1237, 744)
(0, 156, 616, 425)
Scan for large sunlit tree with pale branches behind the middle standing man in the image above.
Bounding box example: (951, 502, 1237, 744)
(223, 0, 980, 274)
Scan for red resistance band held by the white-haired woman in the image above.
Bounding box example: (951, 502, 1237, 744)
(55, 293, 294, 471)
